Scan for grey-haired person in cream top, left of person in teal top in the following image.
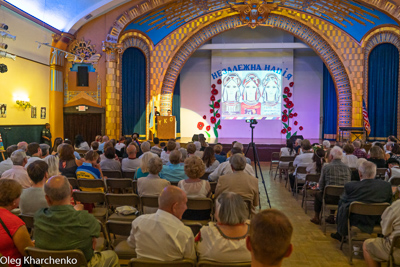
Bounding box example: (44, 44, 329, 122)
(137, 155, 171, 196)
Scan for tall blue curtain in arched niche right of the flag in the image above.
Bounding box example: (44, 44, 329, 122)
(368, 43, 399, 140)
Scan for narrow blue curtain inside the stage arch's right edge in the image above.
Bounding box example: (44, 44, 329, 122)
(322, 64, 338, 140)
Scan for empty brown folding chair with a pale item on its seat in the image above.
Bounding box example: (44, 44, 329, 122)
(106, 194, 140, 222)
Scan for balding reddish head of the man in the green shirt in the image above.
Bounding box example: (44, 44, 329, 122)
(44, 175, 72, 203)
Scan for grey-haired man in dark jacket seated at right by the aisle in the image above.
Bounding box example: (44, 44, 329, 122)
(331, 161, 392, 240)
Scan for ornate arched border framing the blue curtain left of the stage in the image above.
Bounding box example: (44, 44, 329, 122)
(117, 31, 153, 137)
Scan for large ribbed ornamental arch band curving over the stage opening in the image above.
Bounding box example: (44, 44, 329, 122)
(161, 14, 352, 132)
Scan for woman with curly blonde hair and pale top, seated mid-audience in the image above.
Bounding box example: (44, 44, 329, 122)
(178, 155, 211, 198)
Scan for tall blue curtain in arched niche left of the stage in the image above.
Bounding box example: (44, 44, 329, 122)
(122, 47, 146, 135)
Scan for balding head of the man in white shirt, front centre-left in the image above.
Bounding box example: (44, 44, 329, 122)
(158, 185, 187, 219)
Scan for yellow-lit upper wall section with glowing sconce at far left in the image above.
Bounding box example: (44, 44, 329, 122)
(0, 58, 50, 125)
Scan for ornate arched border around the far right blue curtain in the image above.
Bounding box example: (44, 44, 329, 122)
(363, 31, 400, 137)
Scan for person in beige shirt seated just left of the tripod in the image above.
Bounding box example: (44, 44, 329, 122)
(215, 153, 259, 211)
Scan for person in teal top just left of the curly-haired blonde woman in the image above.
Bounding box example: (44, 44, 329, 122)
(160, 150, 188, 182)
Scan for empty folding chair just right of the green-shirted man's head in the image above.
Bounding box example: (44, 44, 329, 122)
(72, 191, 108, 222)
